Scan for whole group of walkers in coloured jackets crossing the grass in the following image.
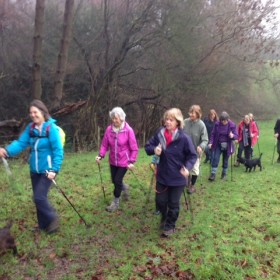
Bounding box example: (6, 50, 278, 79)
(0, 100, 280, 237)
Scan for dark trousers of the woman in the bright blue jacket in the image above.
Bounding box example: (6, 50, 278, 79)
(30, 173, 57, 229)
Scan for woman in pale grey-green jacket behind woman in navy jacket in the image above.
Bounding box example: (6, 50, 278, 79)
(184, 105, 208, 194)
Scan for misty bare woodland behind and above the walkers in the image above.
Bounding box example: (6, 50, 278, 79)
(0, 0, 280, 151)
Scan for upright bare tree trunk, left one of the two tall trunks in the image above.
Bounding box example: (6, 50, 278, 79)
(32, 0, 45, 99)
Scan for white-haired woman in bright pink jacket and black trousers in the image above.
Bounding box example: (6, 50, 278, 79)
(96, 107, 138, 212)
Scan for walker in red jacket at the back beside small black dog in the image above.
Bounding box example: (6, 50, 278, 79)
(234, 115, 259, 166)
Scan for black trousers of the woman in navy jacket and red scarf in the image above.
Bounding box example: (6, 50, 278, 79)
(156, 182, 186, 230)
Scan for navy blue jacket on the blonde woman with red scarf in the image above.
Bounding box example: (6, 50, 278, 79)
(145, 127, 197, 187)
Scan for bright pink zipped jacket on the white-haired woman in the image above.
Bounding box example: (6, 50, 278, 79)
(99, 122, 138, 167)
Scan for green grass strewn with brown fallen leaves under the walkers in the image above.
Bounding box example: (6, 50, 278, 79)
(0, 121, 280, 280)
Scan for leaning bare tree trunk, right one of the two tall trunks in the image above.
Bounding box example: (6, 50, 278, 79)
(52, 0, 74, 109)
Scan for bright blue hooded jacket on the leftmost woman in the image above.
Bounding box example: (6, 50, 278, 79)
(6, 118, 64, 173)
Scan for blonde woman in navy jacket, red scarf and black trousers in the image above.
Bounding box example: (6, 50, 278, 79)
(145, 108, 197, 237)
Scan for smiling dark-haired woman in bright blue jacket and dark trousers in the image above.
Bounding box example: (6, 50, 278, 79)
(0, 100, 63, 233)
